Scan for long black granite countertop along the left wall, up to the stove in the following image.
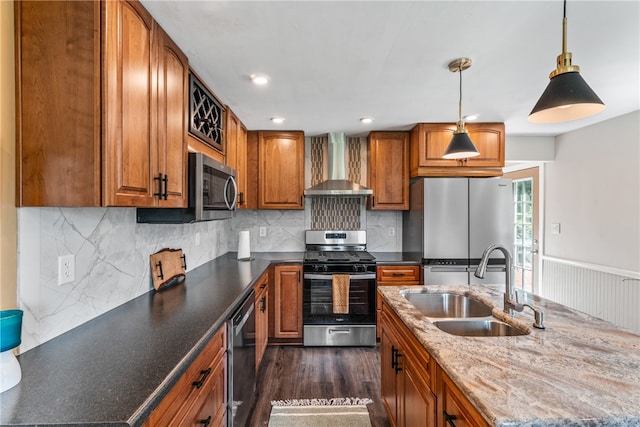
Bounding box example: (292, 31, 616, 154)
(0, 252, 303, 427)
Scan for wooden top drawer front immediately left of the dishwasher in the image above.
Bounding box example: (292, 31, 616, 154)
(145, 326, 226, 426)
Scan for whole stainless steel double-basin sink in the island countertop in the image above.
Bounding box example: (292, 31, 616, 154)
(401, 291, 529, 337)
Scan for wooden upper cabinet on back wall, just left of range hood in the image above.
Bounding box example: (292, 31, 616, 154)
(258, 131, 304, 209)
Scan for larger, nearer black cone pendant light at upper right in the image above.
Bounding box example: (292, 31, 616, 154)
(529, 0, 605, 123)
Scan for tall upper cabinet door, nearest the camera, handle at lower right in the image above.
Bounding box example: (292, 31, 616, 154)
(102, 1, 157, 206)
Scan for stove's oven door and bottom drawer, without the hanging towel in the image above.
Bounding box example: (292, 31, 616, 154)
(302, 273, 376, 346)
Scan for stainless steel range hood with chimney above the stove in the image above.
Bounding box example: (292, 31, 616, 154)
(304, 133, 373, 197)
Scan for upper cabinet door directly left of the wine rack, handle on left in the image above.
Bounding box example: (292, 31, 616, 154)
(153, 27, 189, 207)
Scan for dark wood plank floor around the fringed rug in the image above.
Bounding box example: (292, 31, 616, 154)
(250, 346, 389, 427)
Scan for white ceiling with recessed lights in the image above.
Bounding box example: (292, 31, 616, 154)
(143, 0, 640, 135)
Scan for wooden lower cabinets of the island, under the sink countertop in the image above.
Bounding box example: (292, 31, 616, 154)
(380, 301, 489, 427)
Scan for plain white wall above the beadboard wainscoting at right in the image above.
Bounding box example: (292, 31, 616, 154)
(544, 111, 640, 272)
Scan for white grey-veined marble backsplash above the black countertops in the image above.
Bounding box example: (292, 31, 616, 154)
(18, 204, 402, 352)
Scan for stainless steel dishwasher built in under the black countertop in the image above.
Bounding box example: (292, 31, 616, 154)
(227, 291, 256, 427)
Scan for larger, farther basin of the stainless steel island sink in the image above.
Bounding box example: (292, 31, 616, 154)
(402, 291, 491, 318)
